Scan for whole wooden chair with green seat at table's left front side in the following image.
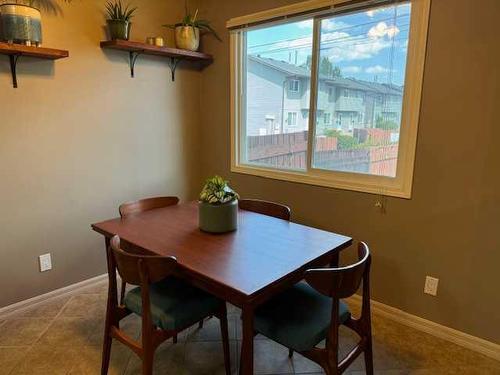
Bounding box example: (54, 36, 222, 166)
(101, 236, 231, 375)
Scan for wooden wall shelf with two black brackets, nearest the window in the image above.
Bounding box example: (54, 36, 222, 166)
(101, 39, 213, 81)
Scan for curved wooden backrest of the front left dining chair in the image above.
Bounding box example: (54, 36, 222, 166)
(109, 236, 177, 285)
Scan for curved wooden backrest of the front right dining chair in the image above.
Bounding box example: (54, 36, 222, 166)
(305, 242, 371, 299)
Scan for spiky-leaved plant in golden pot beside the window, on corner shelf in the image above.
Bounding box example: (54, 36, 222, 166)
(163, 1, 222, 51)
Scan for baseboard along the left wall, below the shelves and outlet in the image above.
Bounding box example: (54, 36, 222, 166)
(0, 273, 108, 319)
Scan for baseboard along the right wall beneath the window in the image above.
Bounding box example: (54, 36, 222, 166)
(349, 295, 500, 361)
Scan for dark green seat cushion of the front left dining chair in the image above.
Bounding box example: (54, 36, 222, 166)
(124, 277, 222, 330)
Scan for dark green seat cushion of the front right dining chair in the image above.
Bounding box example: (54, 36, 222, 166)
(254, 282, 351, 352)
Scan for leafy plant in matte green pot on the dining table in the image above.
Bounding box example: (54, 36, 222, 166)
(198, 176, 239, 233)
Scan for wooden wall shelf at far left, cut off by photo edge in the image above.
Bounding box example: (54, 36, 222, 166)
(0, 42, 69, 88)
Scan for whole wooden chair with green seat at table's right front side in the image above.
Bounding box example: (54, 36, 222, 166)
(254, 242, 373, 375)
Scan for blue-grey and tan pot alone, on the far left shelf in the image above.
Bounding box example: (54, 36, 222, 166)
(0, 4, 42, 45)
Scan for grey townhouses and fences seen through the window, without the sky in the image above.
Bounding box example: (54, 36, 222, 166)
(246, 55, 403, 176)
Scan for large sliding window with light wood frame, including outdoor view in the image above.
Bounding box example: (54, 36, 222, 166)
(228, 0, 430, 198)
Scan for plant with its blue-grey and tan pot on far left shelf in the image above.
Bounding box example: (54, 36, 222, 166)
(0, 0, 75, 46)
